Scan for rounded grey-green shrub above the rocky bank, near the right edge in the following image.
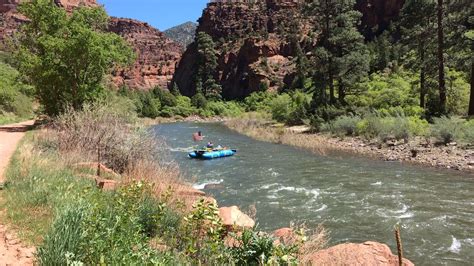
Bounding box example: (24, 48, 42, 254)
(432, 116, 463, 144)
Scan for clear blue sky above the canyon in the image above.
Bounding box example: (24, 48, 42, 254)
(97, 0, 209, 30)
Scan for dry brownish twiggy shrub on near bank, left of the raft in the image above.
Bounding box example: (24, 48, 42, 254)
(52, 104, 157, 173)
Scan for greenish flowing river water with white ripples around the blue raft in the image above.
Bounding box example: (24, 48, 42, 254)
(154, 123, 474, 265)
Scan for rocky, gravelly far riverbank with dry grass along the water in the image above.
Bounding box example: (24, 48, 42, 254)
(224, 119, 474, 174)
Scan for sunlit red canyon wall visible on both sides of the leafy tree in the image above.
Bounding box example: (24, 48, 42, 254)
(0, 0, 183, 89)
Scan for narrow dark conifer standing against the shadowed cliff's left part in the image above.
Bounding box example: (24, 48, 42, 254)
(195, 32, 222, 99)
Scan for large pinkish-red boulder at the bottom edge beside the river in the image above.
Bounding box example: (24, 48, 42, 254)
(305, 242, 414, 266)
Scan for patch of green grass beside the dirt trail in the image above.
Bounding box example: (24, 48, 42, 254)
(2, 132, 94, 245)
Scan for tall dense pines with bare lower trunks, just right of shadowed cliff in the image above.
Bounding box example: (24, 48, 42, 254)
(308, 0, 369, 108)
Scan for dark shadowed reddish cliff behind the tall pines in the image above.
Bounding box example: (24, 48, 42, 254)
(173, 0, 404, 99)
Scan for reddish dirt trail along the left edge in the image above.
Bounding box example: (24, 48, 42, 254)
(0, 121, 35, 266)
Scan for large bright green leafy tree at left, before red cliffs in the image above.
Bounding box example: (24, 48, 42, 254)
(17, 0, 133, 115)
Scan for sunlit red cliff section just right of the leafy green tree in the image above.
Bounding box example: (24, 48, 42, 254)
(109, 18, 183, 89)
